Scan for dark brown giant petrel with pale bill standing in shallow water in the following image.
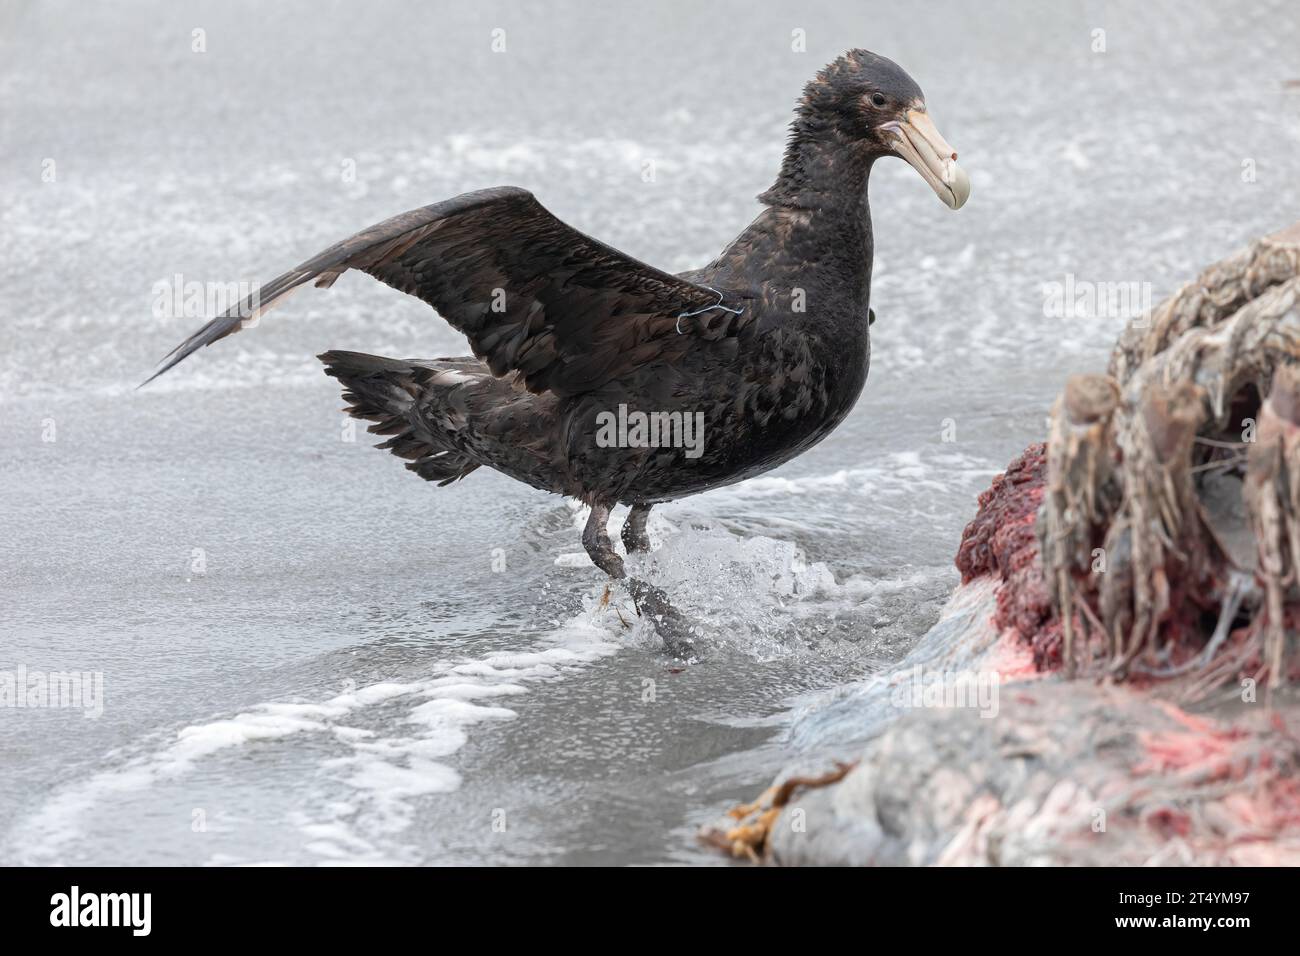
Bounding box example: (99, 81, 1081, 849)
(151, 49, 970, 650)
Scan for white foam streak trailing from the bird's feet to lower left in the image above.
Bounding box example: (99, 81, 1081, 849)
(13, 605, 621, 864)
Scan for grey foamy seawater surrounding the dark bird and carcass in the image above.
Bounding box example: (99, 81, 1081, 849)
(0, 0, 1300, 864)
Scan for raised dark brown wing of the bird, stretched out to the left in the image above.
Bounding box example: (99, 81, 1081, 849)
(146, 186, 749, 395)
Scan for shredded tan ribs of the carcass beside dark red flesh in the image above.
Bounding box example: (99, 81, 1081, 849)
(1037, 225, 1300, 692)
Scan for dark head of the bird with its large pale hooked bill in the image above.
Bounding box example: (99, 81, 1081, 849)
(798, 49, 971, 209)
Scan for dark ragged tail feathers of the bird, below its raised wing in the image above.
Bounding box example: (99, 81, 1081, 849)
(317, 351, 480, 485)
